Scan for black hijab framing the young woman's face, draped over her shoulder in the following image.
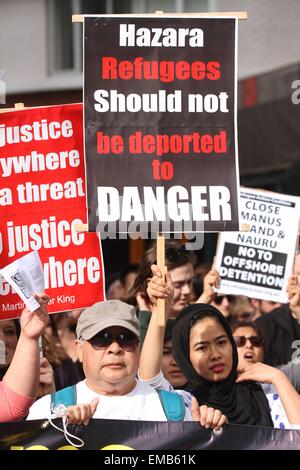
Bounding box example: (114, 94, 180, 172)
(172, 304, 273, 427)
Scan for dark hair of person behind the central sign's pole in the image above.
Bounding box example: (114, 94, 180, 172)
(133, 240, 197, 296)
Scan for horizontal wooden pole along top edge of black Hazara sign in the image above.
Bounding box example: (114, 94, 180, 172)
(72, 11, 248, 23)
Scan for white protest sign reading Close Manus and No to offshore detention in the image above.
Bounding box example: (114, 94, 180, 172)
(215, 188, 300, 303)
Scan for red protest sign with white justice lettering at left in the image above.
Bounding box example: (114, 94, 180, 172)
(0, 104, 104, 319)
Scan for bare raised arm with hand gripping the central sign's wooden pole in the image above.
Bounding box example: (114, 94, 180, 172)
(139, 264, 174, 380)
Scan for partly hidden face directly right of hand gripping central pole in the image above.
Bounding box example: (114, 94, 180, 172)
(170, 263, 194, 317)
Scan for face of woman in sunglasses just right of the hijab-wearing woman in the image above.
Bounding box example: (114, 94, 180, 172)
(233, 326, 264, 372)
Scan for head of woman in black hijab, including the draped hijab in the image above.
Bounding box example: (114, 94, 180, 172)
(172, 304, 273, 427)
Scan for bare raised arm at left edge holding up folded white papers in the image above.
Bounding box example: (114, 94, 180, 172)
(3, 294, 49, 398)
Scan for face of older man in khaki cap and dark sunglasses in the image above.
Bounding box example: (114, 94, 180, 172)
(77, 326, 140, 395)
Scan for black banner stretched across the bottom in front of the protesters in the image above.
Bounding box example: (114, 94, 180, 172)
(0, 419, 300, 451)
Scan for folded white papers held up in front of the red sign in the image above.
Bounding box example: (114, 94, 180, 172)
(0, 251, 44, 312)
